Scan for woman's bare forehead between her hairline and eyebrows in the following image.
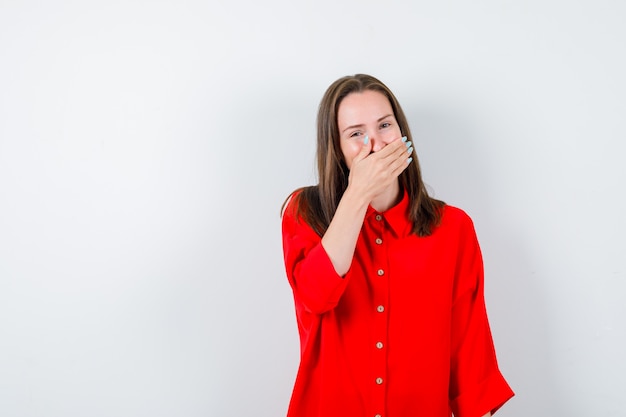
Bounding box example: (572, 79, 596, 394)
(337, 90, 393, 128)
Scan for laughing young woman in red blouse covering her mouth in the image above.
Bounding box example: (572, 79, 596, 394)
(283, 74, 513, 417)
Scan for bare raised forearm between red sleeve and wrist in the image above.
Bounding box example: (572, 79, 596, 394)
(322, 187, 369, 276)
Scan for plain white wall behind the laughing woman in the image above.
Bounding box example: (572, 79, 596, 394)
(0, 0, 626, 417)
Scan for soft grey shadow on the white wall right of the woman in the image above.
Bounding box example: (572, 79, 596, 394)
(405, 102, 564, 417)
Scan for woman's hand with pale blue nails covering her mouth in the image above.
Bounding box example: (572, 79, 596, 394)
(348, 137, 413, 202)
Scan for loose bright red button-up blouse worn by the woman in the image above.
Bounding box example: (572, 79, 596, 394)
(283, 193, 513, 417)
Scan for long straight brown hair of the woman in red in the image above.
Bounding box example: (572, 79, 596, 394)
(283, 74, 445, 236)
